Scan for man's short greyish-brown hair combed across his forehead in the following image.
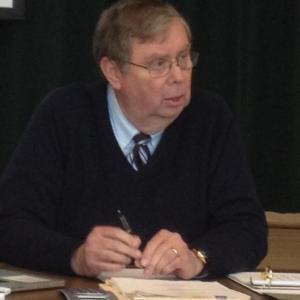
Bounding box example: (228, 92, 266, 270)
(93, 0, 191, 64)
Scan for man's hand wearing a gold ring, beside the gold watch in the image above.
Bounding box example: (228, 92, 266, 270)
(135, 229, 204, 279)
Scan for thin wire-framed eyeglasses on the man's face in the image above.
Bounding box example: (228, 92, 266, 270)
(126, 51, 199, 78)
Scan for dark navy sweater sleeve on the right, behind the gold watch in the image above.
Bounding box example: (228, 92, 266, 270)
(194, 100, 267, 277)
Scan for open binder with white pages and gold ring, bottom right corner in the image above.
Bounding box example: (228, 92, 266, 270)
(228, 272, 300, 299)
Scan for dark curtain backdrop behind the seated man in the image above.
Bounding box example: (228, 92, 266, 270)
(0, 0, 300, 211)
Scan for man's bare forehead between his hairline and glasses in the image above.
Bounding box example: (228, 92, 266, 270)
(131, 19, 190, 58)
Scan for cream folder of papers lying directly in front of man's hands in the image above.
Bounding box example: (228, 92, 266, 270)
(100, 277, 250, 300)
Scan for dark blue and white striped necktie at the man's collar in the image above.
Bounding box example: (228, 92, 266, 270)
(131, 132, 151, 171)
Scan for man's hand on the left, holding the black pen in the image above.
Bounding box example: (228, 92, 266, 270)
(71, 226, 142, 276)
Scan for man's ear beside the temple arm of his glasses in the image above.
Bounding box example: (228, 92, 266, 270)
(99, 56, 123, 90)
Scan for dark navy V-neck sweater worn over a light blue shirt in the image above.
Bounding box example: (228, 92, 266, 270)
(0, 82, 267, 276)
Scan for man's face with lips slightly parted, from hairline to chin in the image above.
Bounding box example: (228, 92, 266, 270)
(114, 19, 192, 133)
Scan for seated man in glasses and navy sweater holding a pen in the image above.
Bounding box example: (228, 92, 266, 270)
(0, 0, 266, 279)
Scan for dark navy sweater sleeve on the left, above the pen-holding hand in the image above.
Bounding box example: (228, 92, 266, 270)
(0, 92, 82, 273)
